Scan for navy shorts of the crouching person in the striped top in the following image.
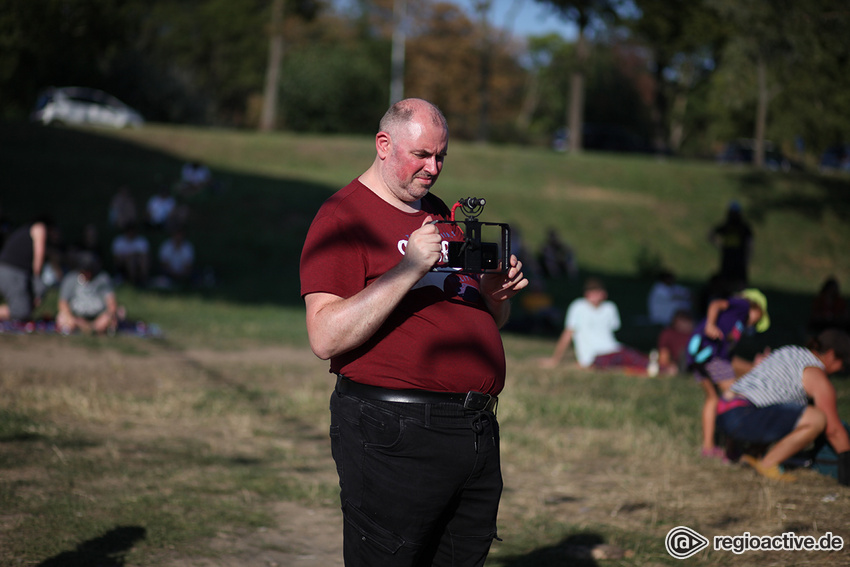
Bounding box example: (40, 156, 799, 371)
(717, 404, 807, 444)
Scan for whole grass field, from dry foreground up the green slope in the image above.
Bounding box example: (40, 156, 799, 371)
(0, 124, 850, 567)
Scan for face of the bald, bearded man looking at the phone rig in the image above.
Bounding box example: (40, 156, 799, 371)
(383, 116, 449, 203)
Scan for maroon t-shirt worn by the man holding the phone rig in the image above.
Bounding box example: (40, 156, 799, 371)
(301, 179, 505, 395)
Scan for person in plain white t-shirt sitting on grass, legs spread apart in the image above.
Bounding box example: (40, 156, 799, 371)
(541, 278, 654, 375)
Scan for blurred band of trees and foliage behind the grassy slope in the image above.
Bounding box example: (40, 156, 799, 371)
(0, 0, 850, 161)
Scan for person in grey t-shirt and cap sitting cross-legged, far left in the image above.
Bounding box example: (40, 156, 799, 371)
(56, 253, 118, 335)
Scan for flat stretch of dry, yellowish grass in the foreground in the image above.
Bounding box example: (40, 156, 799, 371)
(0, 336, 850, 567)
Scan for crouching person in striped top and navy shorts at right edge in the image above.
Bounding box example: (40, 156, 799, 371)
(717, 329, 850, 486)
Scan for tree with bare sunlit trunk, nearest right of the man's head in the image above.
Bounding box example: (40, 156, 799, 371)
(536, 0, 620, 152)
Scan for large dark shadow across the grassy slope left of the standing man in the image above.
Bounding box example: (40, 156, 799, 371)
(0, 123, 339, 305)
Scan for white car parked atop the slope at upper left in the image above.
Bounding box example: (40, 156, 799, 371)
(31, 87, 145, 128)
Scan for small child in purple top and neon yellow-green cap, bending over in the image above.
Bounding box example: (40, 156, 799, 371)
(688, 289, 770, 458)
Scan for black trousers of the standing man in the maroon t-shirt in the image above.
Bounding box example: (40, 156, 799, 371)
(330, 392, 502, 567)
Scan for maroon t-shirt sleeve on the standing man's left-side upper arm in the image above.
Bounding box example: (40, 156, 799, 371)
(300, 213, 366, 298)
